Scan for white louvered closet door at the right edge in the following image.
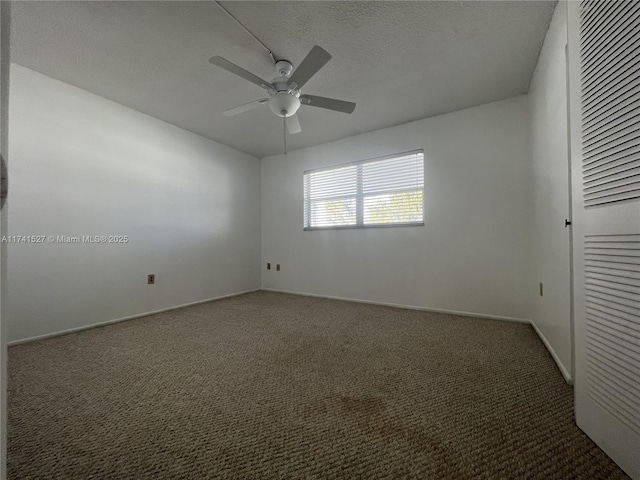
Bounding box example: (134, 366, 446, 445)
(568, 0, 640, 479)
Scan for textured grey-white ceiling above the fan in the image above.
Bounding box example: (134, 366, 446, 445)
(12, 1, 555, 157)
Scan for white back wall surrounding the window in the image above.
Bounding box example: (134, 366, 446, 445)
(262, 96, 531, 319)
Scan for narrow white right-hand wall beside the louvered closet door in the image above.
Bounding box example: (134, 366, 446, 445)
(527, 1, 572, 380)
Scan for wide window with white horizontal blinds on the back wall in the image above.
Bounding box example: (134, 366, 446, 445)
(304, 150, 424, 230)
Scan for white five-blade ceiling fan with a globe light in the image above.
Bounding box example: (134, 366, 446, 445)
(209, 45, 356, 134)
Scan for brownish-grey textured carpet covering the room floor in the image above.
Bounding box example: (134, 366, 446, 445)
(8, 292, 627, 480)
